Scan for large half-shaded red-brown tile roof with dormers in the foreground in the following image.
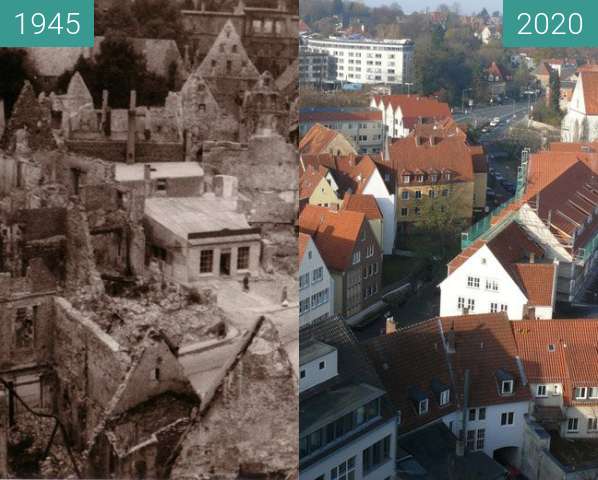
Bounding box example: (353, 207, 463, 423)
(364, 313, 530, 431)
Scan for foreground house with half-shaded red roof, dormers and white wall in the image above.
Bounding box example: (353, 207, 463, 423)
(364, 313, 530, 468)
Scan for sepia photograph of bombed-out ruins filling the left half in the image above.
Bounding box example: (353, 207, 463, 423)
(0, 0, 299, 480)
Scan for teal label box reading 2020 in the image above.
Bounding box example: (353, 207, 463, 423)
(503, 0, 598, 48)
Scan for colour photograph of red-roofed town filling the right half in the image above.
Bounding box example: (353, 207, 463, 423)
(298, 0, 598, 480)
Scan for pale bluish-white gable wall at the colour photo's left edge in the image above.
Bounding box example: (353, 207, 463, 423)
(299, 238, 334, 326)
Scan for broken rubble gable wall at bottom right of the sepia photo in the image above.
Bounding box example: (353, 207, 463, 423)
(170, 320, 299, 480)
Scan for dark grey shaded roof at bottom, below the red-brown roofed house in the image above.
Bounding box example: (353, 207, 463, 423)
(397, 422, 507, 480)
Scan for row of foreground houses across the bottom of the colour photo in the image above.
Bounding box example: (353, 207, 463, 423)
(299, 312, 598, 480)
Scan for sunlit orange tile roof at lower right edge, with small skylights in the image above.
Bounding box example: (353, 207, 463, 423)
(511, 319, 598, 405)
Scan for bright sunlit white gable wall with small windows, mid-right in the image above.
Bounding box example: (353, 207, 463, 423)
(440, 245, 527, 320)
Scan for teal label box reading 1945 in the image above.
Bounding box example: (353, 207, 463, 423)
(0, 0, 94, 47)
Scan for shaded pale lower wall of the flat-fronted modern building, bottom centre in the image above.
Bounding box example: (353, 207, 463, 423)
(299, 417, 396, 480)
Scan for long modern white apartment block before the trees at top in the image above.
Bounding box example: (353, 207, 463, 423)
(306, 37, 415, 84)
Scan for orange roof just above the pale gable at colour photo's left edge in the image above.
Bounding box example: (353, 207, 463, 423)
(299, 205, 367, 272)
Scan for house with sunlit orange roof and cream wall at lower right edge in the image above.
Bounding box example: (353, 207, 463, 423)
(512, 319, 598, 440)
